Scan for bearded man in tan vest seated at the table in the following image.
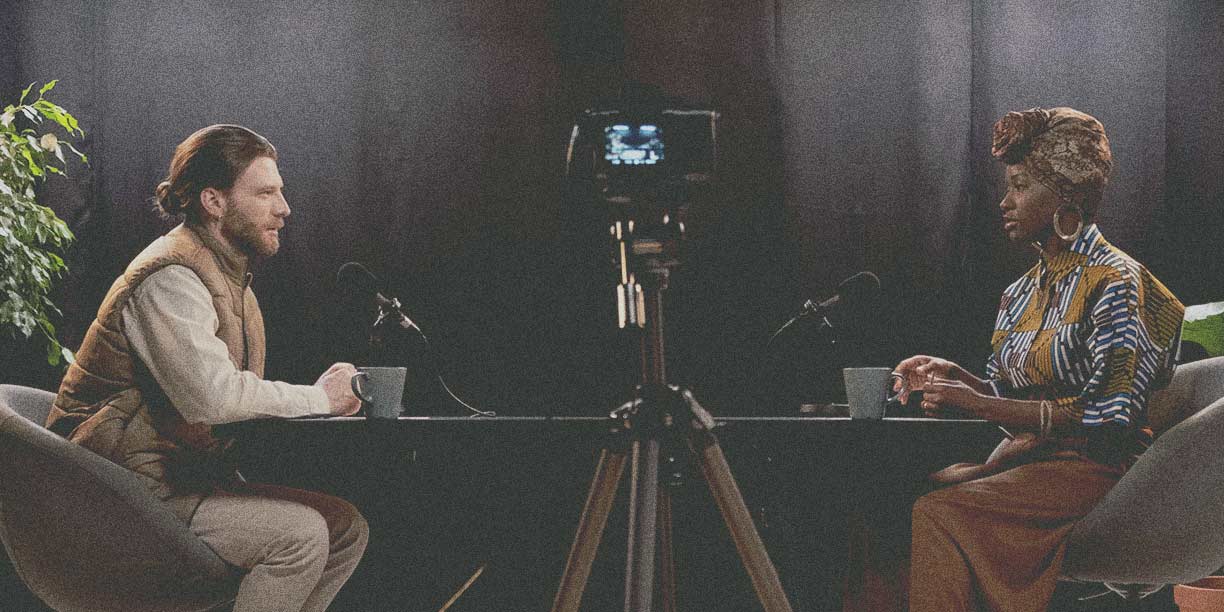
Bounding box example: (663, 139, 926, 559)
(48, 125, 368, 612)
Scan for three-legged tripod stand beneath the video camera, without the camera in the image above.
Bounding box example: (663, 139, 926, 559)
(552, 263, 791, 612)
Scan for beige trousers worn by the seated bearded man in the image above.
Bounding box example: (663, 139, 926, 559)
(191, 485, 370, 612)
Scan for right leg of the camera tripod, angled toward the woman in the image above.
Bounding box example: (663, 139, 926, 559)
(690, 431, 791, 612)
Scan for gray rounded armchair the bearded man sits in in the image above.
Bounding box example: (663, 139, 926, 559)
(0, 384, 239, 612)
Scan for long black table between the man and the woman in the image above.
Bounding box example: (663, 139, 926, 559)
(226, 416, 1001, 612)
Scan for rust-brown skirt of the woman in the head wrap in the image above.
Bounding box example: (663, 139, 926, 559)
(909, 458, 1121, 612)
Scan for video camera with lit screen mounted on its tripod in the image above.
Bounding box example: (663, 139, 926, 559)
(552, 99, 791, 612)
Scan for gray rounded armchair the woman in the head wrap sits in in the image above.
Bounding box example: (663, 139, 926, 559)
(1062, 357, 1224, 592)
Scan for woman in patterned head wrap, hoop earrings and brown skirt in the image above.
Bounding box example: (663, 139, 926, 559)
(897, 108, 1184, 612)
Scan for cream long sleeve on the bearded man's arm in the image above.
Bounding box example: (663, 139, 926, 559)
(122, 266, 329, 425)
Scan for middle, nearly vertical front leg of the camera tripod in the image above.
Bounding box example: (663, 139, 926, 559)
(624, 438, 659, 612)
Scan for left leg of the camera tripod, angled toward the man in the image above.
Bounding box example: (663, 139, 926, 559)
(552, 448, 625, 612)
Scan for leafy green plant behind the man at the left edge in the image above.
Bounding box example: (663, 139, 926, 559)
(0, 81, 88, 367)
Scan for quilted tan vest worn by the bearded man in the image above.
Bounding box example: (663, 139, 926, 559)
(47, 225, 264, 523)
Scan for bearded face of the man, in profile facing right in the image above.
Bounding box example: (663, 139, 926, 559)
(222, 157, 289, 257)
